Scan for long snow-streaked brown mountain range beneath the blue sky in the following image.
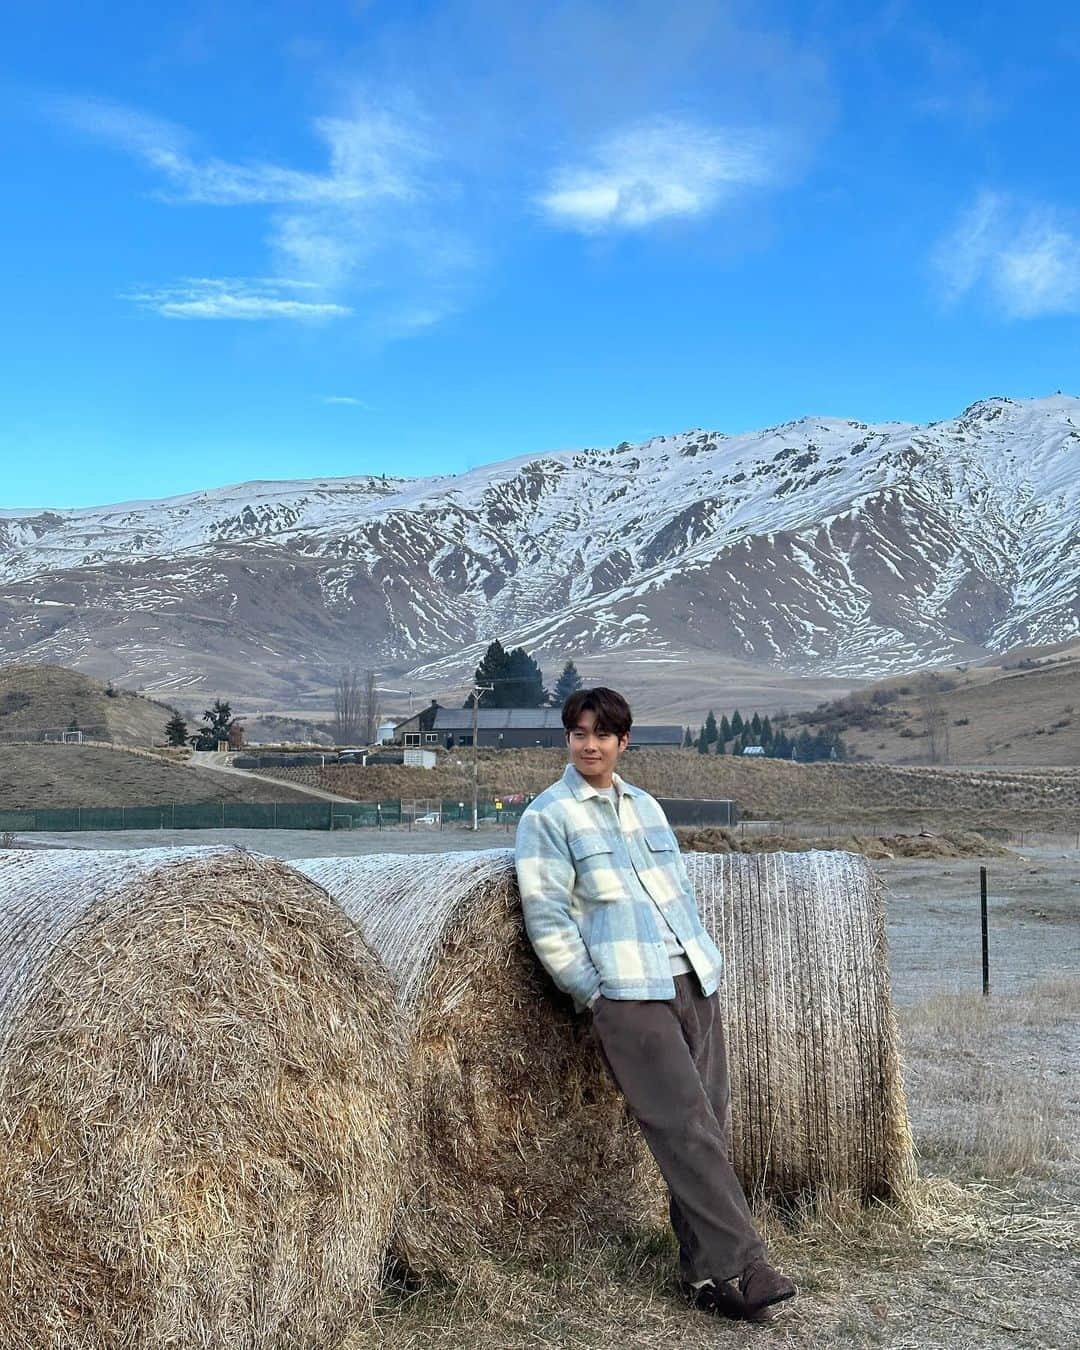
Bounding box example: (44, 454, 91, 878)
(0, 394, 1080, 697)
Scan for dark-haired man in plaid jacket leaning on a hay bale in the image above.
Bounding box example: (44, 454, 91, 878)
(516, 689, 795, 1320)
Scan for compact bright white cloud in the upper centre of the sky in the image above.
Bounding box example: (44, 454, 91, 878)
(537, 117, 772, 234)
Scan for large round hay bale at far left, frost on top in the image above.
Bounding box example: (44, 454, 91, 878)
(0, 849, 402, 1350)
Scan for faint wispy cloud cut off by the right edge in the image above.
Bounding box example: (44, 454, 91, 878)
(933, 192, 1080, 319)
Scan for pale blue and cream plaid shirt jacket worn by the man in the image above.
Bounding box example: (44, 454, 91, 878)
(514, 764, 724, 1007)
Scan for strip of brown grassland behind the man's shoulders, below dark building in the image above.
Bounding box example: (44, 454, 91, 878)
(247, 749, 1080, 830)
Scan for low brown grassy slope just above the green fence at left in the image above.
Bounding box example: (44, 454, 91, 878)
(0, 745, 321, 809)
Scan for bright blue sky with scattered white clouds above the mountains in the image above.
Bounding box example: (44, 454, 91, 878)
(0, 0, 1080, 508)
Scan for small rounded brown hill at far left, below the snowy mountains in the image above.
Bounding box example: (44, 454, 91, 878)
(0, 664, 173, 745)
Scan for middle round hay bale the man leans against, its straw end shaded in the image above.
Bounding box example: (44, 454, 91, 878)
(293, 849, 660, 1276)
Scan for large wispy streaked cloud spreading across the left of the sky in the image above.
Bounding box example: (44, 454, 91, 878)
(50, 99, 450, 326)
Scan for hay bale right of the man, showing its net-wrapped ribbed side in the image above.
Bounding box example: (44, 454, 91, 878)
(686, 852, 913, 1202)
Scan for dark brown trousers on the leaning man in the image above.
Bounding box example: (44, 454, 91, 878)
(591, 975, 765, 1281)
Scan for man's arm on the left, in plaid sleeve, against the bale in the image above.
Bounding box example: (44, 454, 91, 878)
(514, 811, 601, 1006)
